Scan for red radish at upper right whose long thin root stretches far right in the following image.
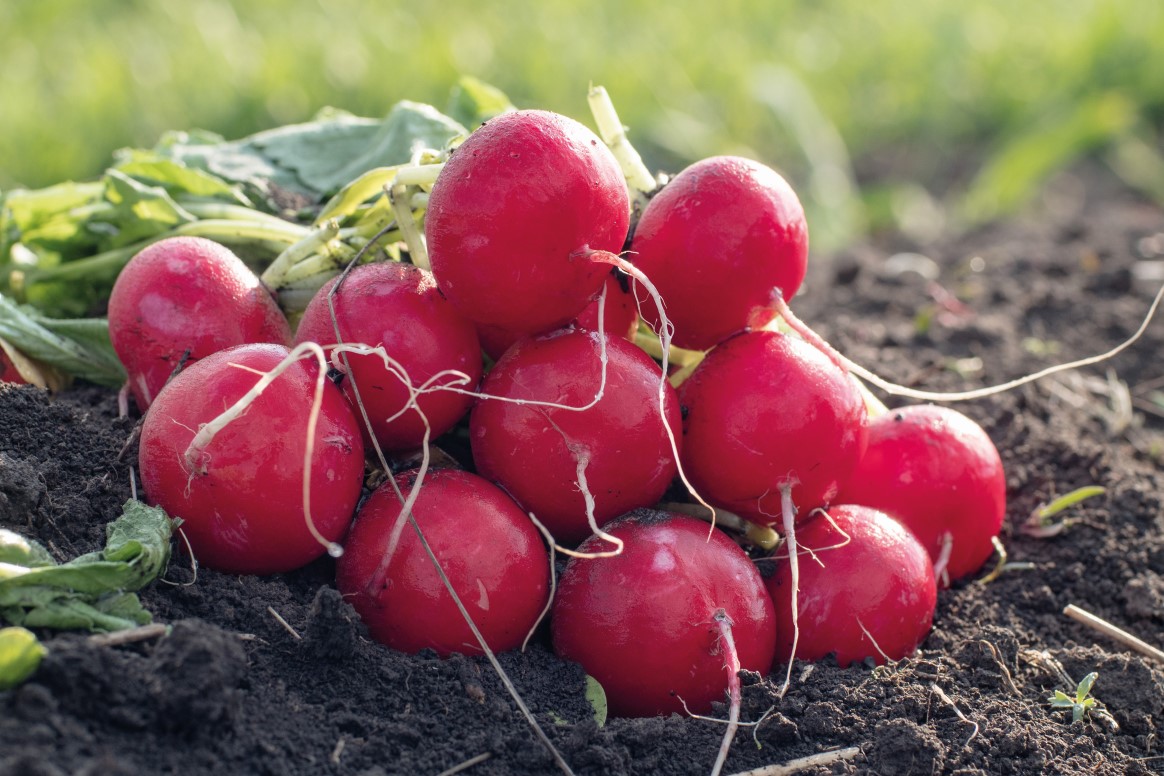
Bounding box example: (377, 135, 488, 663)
(630, 156, 808, 350)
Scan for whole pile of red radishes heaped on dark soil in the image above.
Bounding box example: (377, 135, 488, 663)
(118, 102, 1005, 714)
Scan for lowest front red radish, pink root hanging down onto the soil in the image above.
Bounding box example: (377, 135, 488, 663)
(551, 510, 776, 717)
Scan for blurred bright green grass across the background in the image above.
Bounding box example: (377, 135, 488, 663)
(0, 0, 1164, 245)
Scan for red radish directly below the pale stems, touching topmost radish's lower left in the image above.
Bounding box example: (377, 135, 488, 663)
(296, 262, 482, 451)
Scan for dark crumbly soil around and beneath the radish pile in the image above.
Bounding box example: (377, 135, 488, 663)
(0, 160, 1164, 776)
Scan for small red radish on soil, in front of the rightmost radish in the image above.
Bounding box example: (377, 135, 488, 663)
(765, 505, 937, 665)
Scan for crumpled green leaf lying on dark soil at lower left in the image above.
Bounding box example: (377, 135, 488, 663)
(0, 499, 175, 631)
